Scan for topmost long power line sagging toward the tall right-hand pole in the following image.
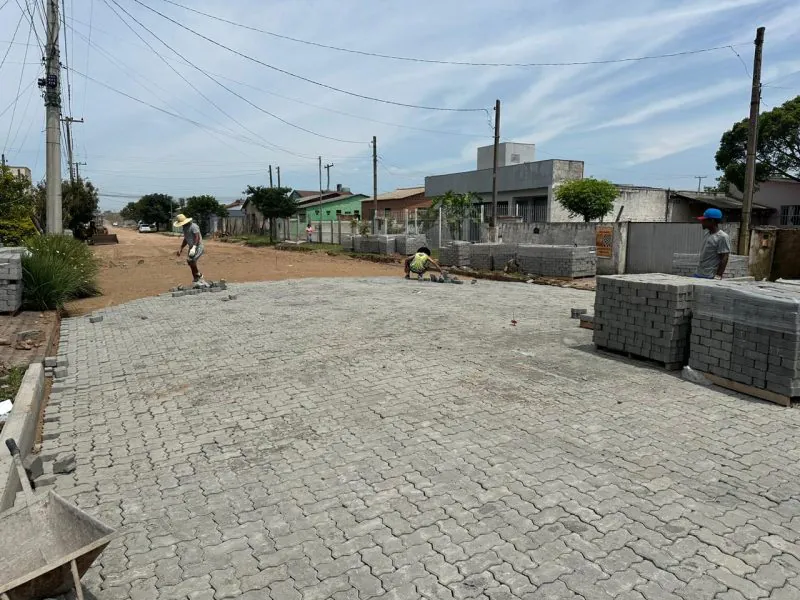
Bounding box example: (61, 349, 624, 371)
(155, 0, 744, 67)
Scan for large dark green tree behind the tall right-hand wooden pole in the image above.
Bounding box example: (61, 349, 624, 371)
(715, 96, 800, 190)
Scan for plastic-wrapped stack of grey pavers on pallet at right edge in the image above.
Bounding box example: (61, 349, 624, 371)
(689, 282, 800, 397)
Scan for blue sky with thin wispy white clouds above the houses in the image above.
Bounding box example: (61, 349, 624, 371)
(0, 0, 800, 209)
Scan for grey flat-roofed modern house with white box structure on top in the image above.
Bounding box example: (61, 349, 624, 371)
(425, 143, 583, 222)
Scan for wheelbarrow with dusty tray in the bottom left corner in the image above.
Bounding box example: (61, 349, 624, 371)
(0, 440, 114, 600)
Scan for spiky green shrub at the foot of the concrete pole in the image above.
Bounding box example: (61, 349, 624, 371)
(22, 235, 99, 310)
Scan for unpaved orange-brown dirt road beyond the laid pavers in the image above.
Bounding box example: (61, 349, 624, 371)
(67, 229, 402, 315)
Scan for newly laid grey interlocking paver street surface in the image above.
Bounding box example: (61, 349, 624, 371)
(44, 278, 800, 600)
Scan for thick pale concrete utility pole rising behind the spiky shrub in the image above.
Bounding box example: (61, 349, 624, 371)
(39, 0, 63, 233)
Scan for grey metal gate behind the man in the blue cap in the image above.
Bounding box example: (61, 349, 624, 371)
(625, 223, 739, 273)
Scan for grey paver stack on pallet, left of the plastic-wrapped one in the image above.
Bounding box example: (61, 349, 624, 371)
(594, 273, 703, 369)
